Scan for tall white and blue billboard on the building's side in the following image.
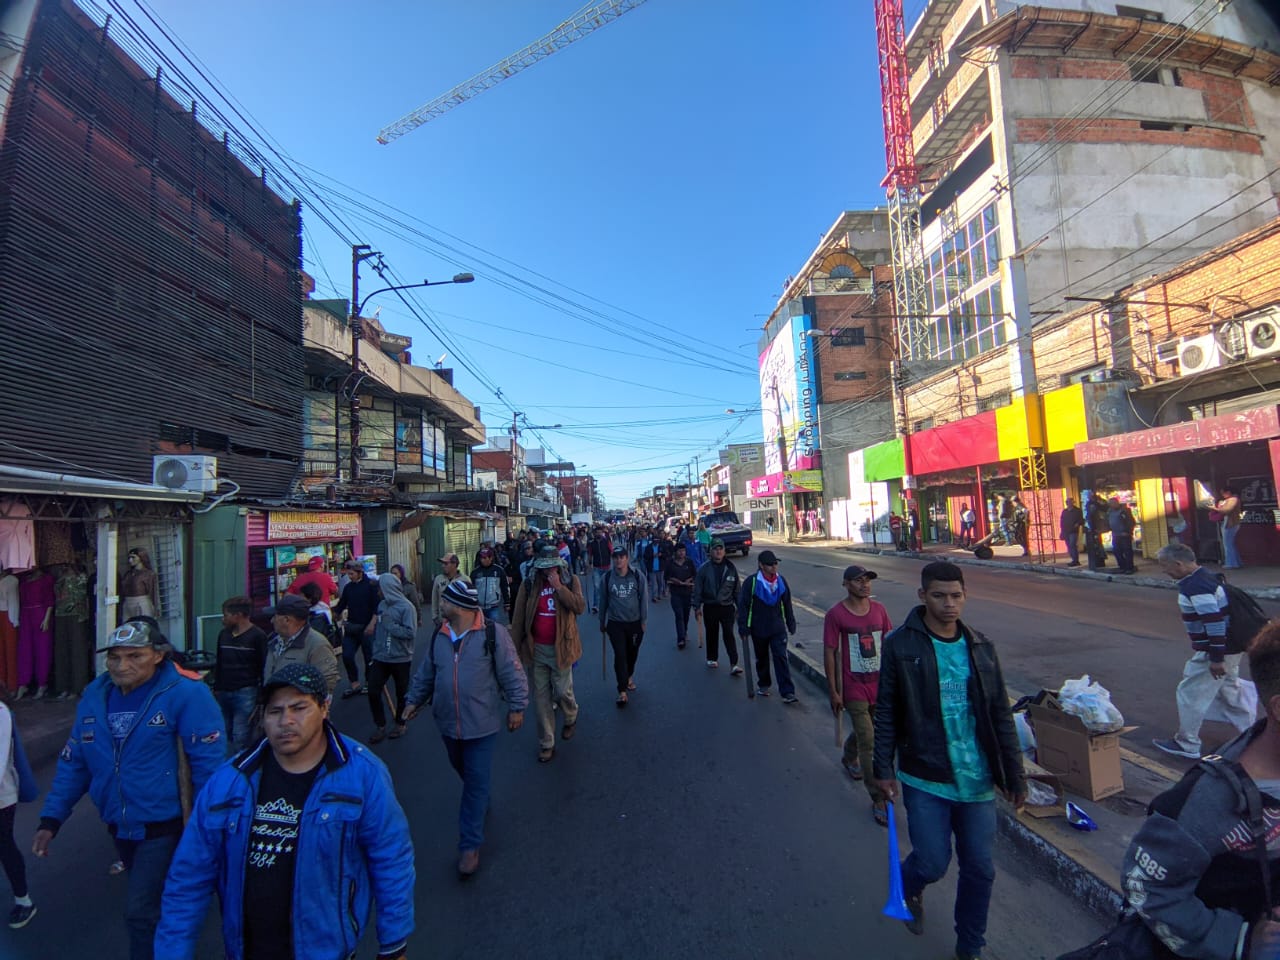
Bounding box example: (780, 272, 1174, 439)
(760, 314, 819, 474)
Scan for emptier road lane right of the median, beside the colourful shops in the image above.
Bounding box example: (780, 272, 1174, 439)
(762, 547, 1264, 769)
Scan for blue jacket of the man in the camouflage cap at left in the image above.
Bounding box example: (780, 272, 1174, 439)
(40, 660, 227, 840)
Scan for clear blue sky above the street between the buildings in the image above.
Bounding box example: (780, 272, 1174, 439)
(140, 0, 896, 506)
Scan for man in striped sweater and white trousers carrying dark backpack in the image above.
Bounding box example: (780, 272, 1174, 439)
(1151, 543, 1261, 760)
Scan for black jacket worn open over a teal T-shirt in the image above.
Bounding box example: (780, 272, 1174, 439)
(874, 605, 1025, 794)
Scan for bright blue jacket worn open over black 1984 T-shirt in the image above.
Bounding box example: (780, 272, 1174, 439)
(155, 722, 413, 960)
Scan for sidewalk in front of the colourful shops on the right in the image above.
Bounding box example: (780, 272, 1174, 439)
(754, 534, 1280, 600)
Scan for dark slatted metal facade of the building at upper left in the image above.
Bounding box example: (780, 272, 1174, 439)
(0, 0, 303, 504)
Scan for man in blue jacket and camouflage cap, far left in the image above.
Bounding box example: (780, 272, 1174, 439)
(32, 621, 227, 960)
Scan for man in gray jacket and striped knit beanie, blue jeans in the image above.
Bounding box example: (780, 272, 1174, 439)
(403, 580, 529, 879)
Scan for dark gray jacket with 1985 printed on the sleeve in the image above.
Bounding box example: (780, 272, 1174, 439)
(1120, 719, 1280, 960)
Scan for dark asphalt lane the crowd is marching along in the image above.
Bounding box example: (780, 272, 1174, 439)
(0, 586, 1098, 960)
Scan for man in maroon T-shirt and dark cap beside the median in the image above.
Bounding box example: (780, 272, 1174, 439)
(822, 564, 892, 827)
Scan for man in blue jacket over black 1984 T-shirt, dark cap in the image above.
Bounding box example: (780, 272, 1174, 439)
(156, 663, 413, 960)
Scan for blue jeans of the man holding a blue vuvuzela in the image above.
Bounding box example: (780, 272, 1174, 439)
(902, 783, 996, 955)
